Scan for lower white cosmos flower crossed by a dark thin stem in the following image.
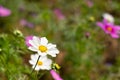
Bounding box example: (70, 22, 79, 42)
(29, 54, 52, 71)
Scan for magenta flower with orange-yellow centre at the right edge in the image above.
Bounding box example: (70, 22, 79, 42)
(97, 19, 120, 38)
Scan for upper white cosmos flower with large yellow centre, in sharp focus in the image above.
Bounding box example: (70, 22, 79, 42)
(28, 36, 59, 57)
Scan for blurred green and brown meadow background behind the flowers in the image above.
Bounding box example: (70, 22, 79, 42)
(0, 0, 120, 80)
